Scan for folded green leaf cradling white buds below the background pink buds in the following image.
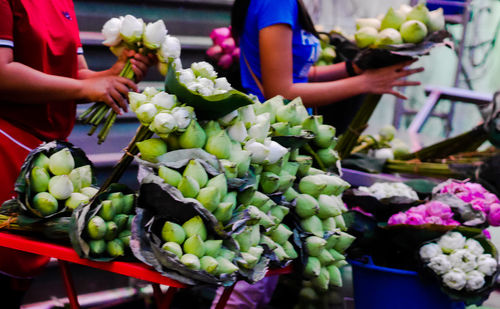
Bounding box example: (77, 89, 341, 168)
(165, 64, 253, 120)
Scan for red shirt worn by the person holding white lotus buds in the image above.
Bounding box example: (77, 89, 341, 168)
(0, 0, 82, 141)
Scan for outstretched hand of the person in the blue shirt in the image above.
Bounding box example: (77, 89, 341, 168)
(361, 60, 424, 100)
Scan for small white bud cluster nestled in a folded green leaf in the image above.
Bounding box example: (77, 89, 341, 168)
(177, 61, 232, 96)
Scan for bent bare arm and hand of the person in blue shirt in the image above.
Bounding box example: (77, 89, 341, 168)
(259, 24, 422, 106)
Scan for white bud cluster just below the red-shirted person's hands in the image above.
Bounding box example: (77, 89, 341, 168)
(129, 87, 196, 137)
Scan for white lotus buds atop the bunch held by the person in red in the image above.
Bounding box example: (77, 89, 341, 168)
(102, 15, 182, 74)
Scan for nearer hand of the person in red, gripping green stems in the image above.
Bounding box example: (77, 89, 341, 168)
(80, 76, 137, 115)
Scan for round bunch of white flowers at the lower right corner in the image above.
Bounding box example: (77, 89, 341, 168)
(419, 232, 498, 292)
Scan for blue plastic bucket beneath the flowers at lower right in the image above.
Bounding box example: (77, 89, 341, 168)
(349, 261, 465, 309)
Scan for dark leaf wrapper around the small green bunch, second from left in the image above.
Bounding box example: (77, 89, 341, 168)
(69, 184, 137, 262)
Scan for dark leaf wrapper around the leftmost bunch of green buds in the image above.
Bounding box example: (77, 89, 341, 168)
(8, 141, 97, 221)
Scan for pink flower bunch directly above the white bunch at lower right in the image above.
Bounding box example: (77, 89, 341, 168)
(387, 201, 460, 225)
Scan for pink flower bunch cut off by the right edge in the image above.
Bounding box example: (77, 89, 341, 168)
(439, 181, 500, 226)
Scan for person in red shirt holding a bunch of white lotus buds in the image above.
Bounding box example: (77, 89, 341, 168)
(0, 0, 155, 308)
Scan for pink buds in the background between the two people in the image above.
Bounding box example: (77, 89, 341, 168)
(207, 27, 240, 69)
